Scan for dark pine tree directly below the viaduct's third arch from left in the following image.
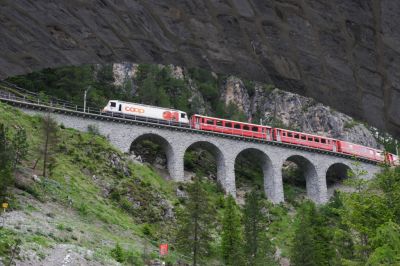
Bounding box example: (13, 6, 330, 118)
(243, 191, 274, 266)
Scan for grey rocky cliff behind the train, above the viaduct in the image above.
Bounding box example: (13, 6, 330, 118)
(113, 63, 381, 149)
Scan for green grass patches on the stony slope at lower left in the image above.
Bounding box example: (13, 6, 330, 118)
(0, 103, 189, 261)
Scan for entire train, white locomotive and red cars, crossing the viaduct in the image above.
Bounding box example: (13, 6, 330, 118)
(102, 100, 400, 166)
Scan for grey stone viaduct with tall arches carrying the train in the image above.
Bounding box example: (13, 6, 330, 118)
(8, 103, 380, 203)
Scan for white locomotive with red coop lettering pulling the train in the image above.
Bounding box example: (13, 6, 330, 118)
(103, 100, 189, 124)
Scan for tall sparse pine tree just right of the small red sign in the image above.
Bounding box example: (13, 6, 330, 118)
(176, 177, 215, 266)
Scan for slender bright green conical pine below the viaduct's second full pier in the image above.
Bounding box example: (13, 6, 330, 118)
(222, 195, 244, 266)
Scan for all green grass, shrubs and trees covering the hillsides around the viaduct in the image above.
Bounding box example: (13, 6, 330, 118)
(0, 62, 400, 265)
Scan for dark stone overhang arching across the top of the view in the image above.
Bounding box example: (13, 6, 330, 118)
(0, 0, 400, 135)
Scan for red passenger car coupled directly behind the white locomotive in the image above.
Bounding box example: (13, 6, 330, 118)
(190, 115, 273, 140)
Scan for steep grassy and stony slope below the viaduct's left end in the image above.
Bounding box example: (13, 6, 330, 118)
(0, 104, 185, 265)
